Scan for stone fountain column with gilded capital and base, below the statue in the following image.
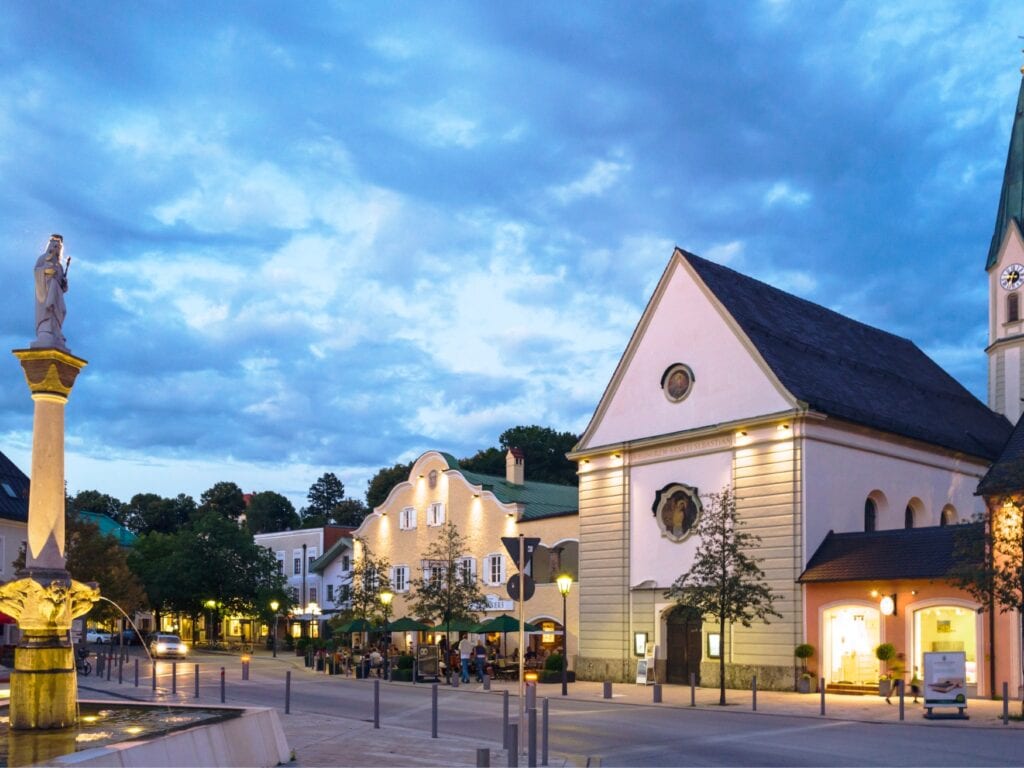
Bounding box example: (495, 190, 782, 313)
(0, 349, 99, 730)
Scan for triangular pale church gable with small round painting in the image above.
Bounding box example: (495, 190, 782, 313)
(577, 250, 795, 451)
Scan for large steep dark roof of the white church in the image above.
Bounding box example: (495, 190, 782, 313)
(680, 251, 1011, 461)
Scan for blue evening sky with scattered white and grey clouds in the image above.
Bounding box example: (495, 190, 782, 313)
(0, 0, 1024, 514)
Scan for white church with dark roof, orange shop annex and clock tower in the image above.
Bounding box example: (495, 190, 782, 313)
(570, 73, 1024, 695)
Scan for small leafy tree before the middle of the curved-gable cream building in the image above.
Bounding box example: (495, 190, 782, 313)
(411, 520, 485, 628)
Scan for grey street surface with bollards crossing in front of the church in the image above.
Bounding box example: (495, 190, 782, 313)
(79, 649, 1024, 766)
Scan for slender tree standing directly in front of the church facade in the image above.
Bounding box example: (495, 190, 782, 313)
(666, 486, 781, 706)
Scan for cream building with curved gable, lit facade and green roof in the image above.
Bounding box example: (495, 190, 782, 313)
(354, 451, 579, 666)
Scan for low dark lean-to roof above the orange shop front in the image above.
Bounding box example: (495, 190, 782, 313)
(797, 523, 983, 584)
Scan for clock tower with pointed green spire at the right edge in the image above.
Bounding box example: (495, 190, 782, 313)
(985, 68, 1024, 424)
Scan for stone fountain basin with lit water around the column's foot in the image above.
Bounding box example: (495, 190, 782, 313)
(0, 700, 291, 768)
